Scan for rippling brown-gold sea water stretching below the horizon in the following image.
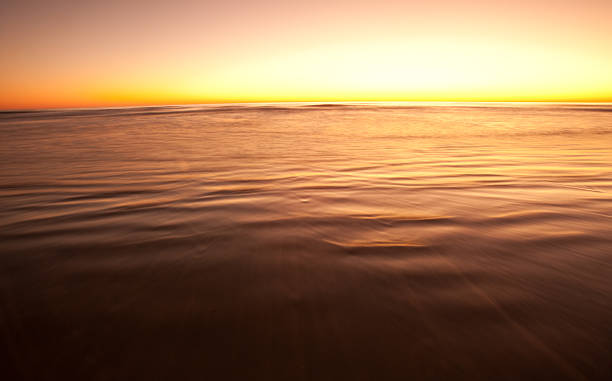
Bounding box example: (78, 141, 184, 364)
(0, 103, 612, 380)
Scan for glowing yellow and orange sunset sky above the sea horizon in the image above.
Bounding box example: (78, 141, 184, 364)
(0, 0, 612, 109)
